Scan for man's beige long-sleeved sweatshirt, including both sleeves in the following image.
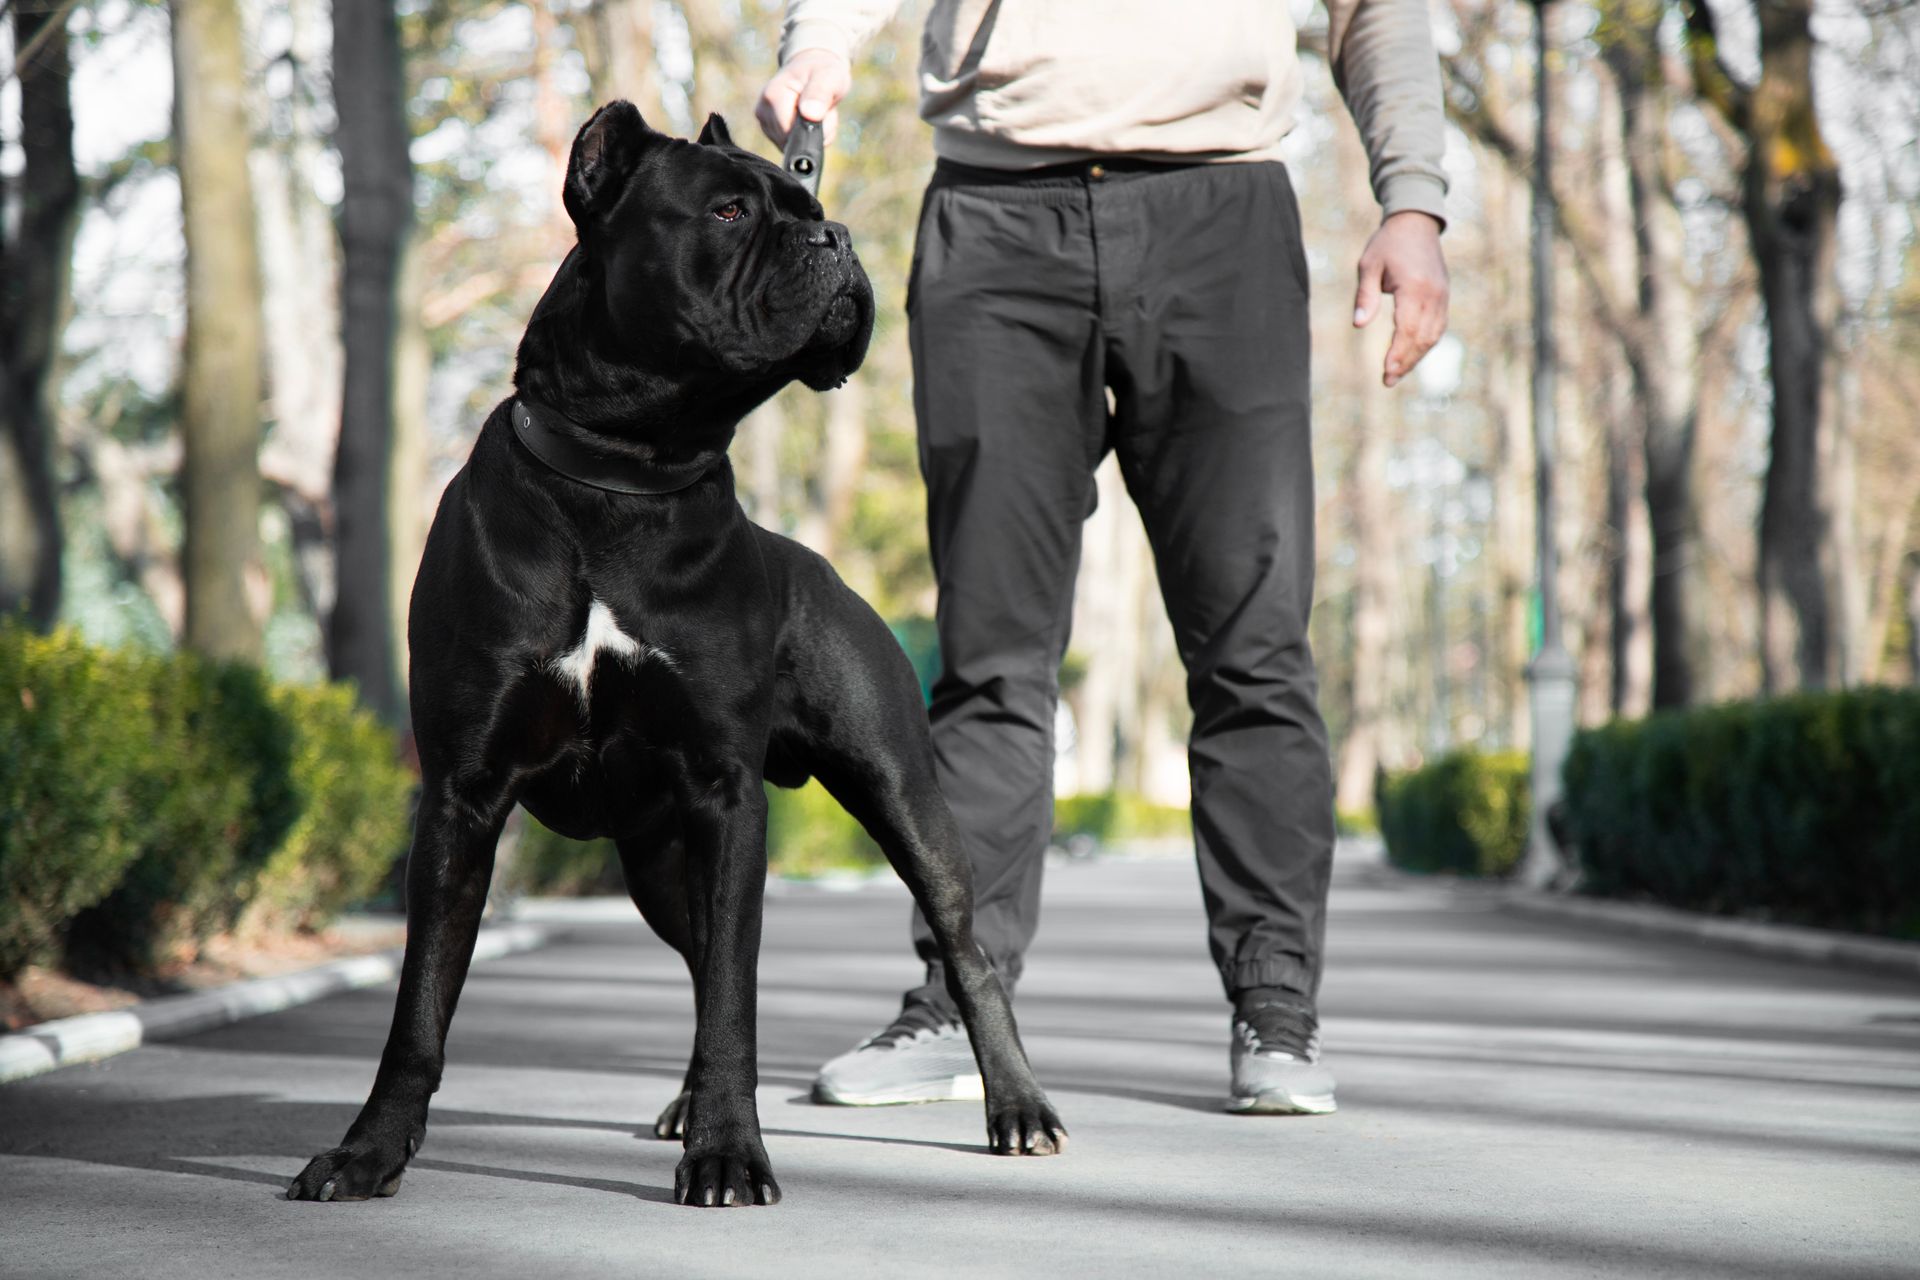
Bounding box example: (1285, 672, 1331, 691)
(780, 0, 1446, 221)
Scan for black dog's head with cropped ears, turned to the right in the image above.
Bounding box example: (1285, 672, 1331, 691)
(564, 102, 874, 393)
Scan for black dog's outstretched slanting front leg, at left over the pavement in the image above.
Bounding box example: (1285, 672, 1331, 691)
(286, 779, 513, 1199)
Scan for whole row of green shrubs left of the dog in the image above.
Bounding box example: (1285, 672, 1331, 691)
(0, 624, 413, 979)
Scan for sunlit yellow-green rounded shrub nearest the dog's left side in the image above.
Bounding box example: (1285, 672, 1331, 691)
(244, 685, 415, 933)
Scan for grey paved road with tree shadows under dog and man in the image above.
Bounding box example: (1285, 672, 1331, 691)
(0, 844, 1920, 1280)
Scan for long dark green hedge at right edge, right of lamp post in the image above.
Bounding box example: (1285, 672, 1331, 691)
(1563, 689, 1920, 936)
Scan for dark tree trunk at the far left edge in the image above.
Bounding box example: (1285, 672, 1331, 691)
(0, 0, 81, 629)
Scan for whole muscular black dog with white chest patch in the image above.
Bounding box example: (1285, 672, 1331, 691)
(288, 102, 1066, 1205)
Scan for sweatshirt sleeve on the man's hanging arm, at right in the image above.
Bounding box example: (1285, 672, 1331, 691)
(1328, 0, 1448, 225)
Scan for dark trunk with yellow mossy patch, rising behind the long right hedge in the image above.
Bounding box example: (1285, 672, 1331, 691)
(1743, 0, 1841, 693)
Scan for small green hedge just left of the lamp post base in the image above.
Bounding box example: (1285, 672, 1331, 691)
(1375, 750, 1530, 875)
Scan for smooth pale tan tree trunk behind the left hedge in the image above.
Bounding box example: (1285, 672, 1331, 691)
(173, 0, 267, 662)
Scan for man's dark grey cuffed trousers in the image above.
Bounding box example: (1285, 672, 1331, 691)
(906, 161, 1332, 1004)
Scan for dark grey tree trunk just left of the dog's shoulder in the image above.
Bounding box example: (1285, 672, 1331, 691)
(326, 0, 413, 723)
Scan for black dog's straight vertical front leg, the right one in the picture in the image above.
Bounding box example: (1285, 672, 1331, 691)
(674, 768, 780, 1205)
